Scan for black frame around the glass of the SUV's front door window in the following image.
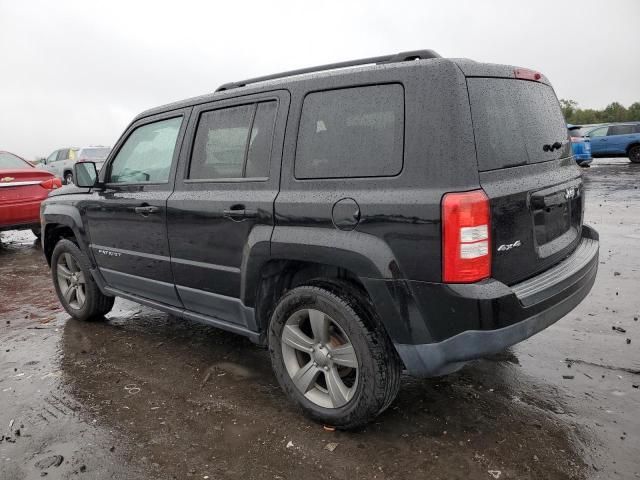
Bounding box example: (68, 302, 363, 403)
(101, 107, 191, 189)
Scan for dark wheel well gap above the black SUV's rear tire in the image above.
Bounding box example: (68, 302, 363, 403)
(255, 260, 375, 332)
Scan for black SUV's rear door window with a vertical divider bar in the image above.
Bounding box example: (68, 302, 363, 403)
(189, 101, 277, 180)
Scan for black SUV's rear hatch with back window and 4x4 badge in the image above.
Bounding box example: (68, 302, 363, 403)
(467, 77, 584, 285)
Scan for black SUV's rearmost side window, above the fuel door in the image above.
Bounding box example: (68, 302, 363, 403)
(295, 84, 404, 178)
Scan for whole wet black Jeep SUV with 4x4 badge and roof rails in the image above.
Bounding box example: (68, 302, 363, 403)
(42, 50, 598, 428)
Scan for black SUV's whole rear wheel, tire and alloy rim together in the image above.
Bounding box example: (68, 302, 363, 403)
(269, 285, 401, 429)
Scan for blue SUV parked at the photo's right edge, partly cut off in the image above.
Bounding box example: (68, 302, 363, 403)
(586, 122, 640, 163)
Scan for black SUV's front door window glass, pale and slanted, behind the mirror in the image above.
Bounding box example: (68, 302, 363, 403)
(109, 117, 182, 183)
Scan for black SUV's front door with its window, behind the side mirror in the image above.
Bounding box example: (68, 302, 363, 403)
(86, 110, 189, 307)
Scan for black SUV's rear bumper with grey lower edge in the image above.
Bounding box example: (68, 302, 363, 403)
(365, 225, 599, 377)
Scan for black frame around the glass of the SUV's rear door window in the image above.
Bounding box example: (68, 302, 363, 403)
(182, 96, 282, 184)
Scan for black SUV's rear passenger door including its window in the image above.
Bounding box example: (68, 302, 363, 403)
(167, 91, 289, 329)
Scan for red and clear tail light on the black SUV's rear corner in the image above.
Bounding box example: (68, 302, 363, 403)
(442, 190, 491, 283)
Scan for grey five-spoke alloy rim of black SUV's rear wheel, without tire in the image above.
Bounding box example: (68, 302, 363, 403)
(281, 309, 358, 408)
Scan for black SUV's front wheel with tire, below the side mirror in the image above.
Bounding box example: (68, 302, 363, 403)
(51, 239, 115, 320)
